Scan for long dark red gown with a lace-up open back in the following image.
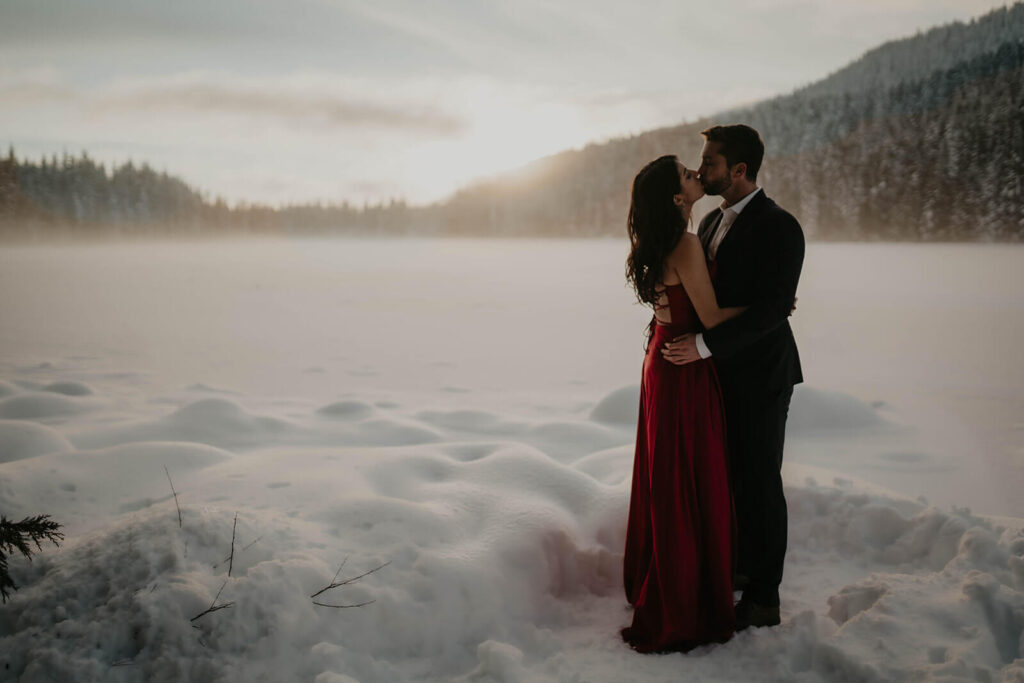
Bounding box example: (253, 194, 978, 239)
(622, 285, 735, 652)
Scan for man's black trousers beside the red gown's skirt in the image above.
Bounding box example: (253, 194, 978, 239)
(722, 387, 793, 605)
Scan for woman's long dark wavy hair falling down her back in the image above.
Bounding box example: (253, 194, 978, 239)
(626, 155, 686, 304)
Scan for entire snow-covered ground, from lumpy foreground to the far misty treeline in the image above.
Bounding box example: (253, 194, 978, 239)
(0, 240, 1024, 683)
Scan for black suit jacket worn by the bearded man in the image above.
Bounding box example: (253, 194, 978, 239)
(697, 189, 804, 394)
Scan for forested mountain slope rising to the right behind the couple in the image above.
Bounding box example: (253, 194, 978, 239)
(442, 3, 1024, 241)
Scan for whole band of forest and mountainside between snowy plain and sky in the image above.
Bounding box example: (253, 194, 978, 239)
(0, 3, 1024, 241)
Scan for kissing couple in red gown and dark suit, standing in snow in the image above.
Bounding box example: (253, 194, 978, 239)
(621, 125, 804, 652)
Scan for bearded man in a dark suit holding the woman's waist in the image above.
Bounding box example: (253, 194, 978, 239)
(663, 125, 804, 631)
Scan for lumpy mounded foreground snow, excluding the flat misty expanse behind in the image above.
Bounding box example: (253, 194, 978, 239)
(0, 378, 1024, 683)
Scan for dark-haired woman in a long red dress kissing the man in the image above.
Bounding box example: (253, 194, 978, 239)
(622, 156, 743, 652)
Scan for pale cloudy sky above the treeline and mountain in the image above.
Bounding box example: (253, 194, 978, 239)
(0, 0, 1005, 205)
